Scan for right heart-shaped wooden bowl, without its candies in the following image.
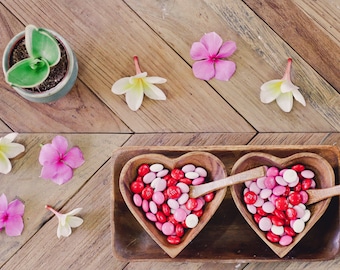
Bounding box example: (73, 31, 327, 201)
(231, 152, 335, 258)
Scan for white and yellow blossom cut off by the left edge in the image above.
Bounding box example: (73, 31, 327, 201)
(0, 132, 25, 174)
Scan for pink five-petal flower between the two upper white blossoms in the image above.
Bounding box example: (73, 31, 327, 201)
(190, 32, 236, 81)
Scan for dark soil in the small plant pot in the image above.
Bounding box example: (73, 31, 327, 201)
(9, 38, 68, 92)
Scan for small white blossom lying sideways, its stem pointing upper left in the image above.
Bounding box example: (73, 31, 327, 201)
(45, 205, 83, 238)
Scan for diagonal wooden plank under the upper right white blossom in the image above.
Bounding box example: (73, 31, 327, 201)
(126, 0, 340, 132)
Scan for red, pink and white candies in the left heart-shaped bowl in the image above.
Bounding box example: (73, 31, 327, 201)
(130, 163, 215, 244)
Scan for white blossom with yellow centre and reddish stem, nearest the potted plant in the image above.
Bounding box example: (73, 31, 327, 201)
(111, 56, 166, 111)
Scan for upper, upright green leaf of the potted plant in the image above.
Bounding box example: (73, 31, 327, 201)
(25, 25, 61, 66)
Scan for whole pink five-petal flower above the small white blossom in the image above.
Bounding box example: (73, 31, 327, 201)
(39, 135, 84, 185)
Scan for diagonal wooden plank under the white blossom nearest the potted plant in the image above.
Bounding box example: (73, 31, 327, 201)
(3, 0, 254, 132)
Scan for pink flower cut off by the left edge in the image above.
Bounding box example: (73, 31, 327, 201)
(0, 194, 25, 236)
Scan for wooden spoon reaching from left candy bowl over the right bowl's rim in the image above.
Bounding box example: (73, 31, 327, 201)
(189, 166, 266, 198)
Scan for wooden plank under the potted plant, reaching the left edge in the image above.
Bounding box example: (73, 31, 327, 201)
(0, 5, 130, 133)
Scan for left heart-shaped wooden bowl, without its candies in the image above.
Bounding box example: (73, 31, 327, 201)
(119, 152, 227, 258)
